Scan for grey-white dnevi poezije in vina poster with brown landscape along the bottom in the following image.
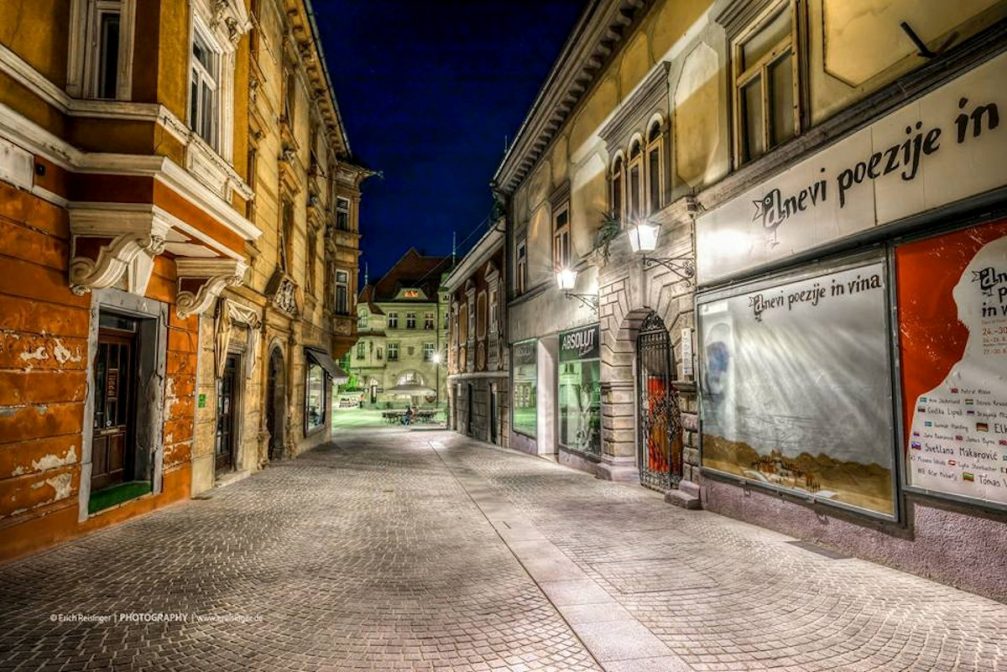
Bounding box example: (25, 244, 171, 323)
(699, 261, 895, 516)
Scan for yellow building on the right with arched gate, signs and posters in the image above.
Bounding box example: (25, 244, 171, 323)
(494, 0, 1007, 596)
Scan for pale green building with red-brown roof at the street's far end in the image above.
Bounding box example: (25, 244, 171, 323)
(349, 248, 451, 407)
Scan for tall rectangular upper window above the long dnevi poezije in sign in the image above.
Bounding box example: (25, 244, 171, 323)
(732, 1, 801, 165)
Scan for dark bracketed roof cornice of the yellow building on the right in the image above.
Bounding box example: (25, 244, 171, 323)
(493, 0, 653, 193)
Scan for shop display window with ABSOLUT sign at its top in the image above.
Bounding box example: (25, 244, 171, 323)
(557, 324, 601, 455)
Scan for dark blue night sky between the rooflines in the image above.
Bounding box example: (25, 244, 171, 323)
(312, 0, 584, 282)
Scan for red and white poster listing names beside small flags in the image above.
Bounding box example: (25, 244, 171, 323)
(895, 222, 1007, 505)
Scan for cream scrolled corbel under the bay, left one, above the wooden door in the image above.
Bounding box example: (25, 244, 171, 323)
(69, 207, 171, 296)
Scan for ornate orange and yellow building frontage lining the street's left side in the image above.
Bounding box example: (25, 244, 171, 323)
(0, 0, 367, 558)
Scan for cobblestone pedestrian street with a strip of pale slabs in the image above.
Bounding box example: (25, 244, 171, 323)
(0, 429, 1007, 672)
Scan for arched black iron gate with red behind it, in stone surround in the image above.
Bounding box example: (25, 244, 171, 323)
(636, 312, 682, 491)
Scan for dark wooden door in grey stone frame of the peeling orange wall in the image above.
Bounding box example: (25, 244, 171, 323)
(91, 315, 137, 492)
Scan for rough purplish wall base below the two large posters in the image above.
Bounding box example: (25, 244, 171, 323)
(701, 477, 1007, 601)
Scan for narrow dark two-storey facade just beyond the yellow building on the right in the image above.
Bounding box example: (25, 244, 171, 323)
(444, 227, 511, 445)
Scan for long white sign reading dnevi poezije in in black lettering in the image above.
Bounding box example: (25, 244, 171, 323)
(696, 54, 1007, 284)
